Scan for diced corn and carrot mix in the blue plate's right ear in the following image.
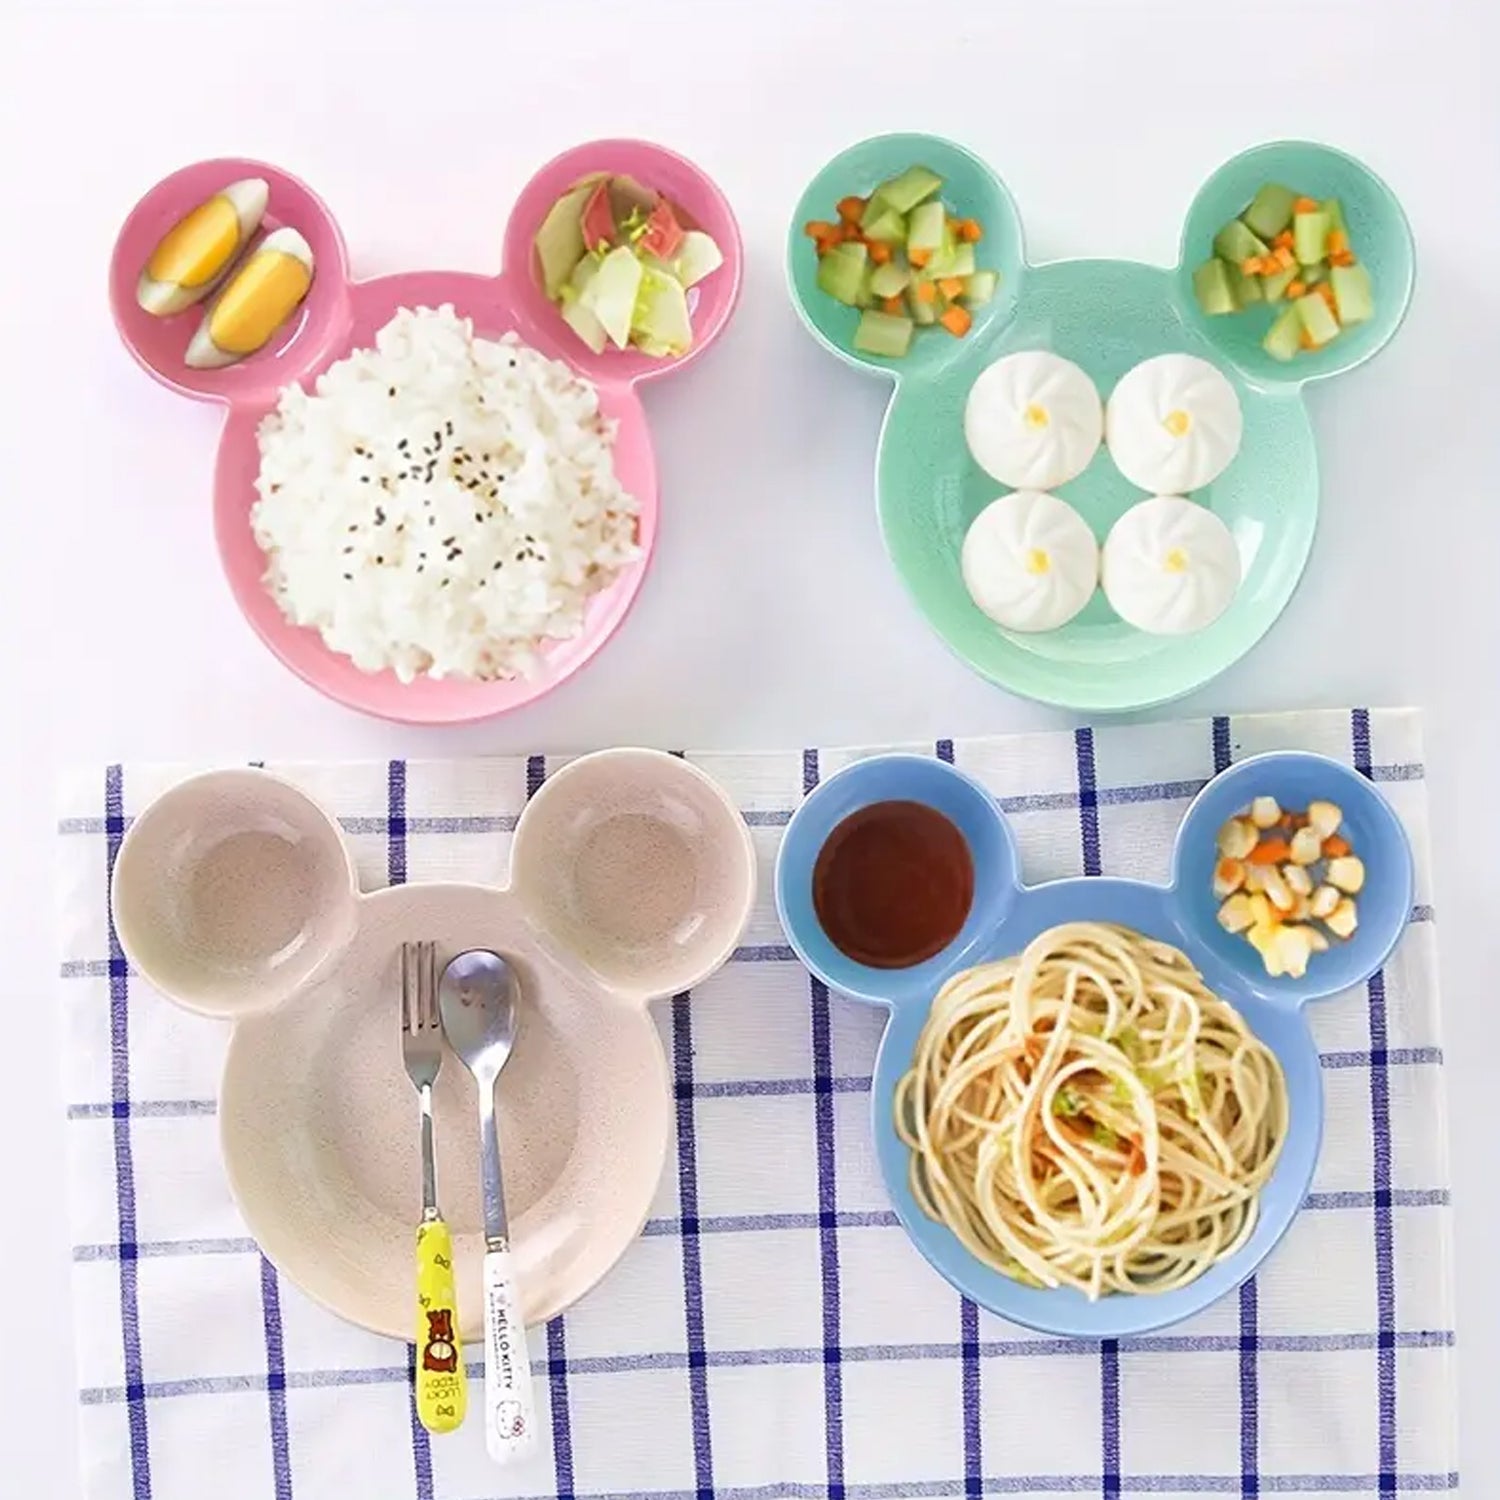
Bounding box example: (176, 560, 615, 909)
(1214, 797, 1365, 980)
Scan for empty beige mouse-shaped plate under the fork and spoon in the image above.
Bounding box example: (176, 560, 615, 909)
(114, 750, 755, 1338)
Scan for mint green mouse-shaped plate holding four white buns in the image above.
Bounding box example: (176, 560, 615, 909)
(786, 134, 1415, 713)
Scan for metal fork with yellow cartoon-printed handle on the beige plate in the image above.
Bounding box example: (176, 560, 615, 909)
(401, 942, 468, 1433)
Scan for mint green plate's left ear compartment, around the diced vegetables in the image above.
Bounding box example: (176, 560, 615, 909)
(786, 132, 1026, 380)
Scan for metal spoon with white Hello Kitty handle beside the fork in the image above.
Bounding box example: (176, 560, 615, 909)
(438, 948, 537, 1464)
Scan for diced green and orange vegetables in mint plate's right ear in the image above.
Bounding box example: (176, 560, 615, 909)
(1193, 183, 1376, 360)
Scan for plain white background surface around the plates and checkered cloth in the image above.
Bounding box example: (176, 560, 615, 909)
(0, 0, 1500, 1500)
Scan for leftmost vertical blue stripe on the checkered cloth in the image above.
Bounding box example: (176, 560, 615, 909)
(104, 765, 152, 1500)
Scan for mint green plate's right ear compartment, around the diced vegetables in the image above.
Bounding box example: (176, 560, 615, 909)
(1176, 141, 1416, 386)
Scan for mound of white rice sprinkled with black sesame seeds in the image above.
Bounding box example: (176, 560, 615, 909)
(251, 306, 641, 683)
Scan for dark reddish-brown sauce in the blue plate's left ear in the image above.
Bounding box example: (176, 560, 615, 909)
(813, 803, 974, 969)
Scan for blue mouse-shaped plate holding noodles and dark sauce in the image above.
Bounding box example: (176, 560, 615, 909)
(776, 752, 1413, 1338)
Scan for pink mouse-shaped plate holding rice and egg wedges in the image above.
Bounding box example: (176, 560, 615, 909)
(110, 141, 744, 725)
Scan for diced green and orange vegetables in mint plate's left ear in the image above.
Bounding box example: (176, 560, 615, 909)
(804, 167, 1001, 359)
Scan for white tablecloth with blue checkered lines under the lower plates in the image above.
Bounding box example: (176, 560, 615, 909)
(55, 710, 1458, 1500)
